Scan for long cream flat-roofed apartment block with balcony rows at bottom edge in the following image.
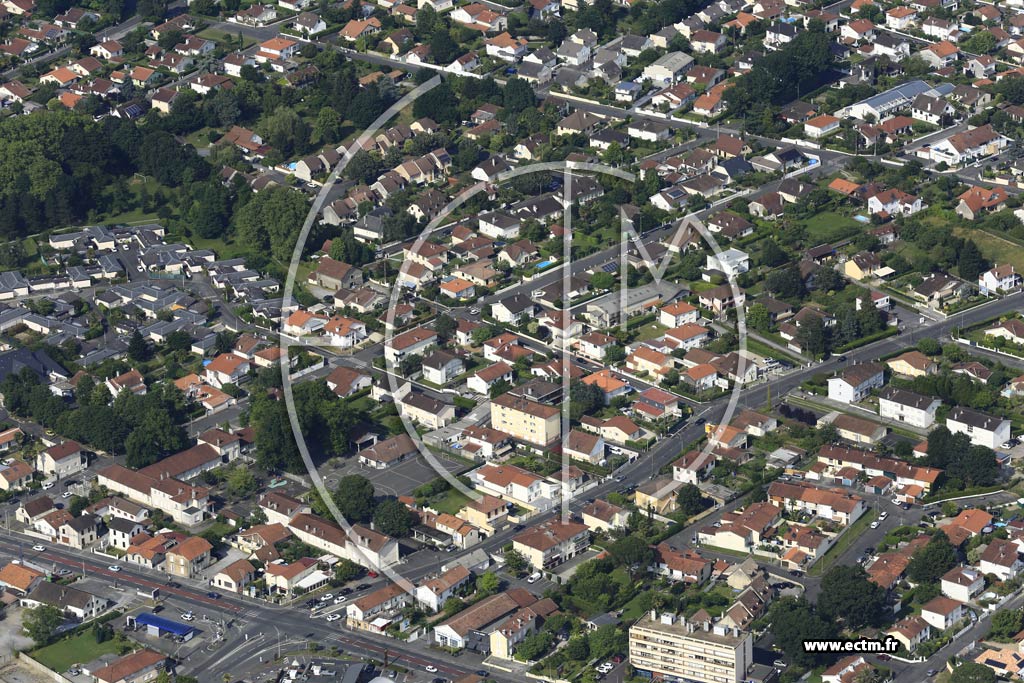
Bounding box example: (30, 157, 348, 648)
(629, 610, 754, 683)
